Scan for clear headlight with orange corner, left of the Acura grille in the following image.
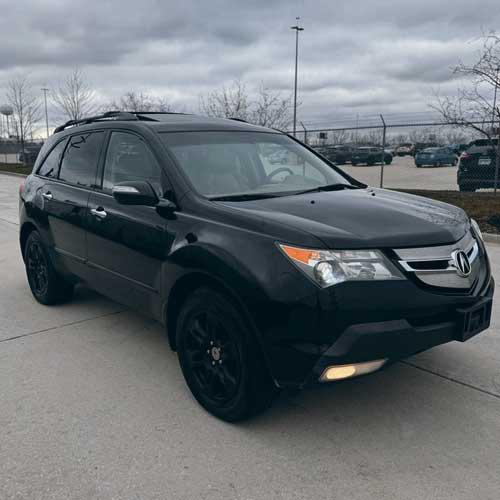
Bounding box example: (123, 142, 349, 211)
(279, 244, 404, 288)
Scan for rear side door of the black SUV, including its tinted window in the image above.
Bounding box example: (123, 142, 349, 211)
(40, 131, 104, 275)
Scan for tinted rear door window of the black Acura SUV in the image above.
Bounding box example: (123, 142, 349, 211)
(59, 132, 104, 186)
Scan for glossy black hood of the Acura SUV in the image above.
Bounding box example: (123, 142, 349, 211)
(219, 188, 469, 249)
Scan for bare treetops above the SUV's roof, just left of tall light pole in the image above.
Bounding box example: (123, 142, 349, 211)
(199, 80, 292, 129)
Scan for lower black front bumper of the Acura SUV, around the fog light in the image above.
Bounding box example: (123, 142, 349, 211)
(268, 278, 494, 388)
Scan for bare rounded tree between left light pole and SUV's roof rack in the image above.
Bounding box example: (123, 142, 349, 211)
(52, 68, 96, 120)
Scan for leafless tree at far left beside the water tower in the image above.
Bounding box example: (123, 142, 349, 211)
(6, 75, 40, 151)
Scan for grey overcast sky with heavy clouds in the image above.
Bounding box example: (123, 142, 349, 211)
(0, 0, 500, 131)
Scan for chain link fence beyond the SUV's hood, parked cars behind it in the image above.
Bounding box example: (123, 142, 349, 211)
(297, 113, 500, 193)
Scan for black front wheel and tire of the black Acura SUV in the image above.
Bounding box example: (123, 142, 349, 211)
(177, 287, 277, 422)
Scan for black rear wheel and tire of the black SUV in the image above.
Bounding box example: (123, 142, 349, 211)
(24, 231, 74, 306)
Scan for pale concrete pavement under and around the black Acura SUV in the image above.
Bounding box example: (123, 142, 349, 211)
(0, 175, 500, 500)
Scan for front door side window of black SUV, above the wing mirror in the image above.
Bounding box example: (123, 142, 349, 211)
(103, 132, 163, 196)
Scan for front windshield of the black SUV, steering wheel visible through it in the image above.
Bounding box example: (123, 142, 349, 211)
(160, 132, 349, 197)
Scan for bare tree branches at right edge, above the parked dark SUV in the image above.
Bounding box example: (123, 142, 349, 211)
(431, 32, 500, 140)
